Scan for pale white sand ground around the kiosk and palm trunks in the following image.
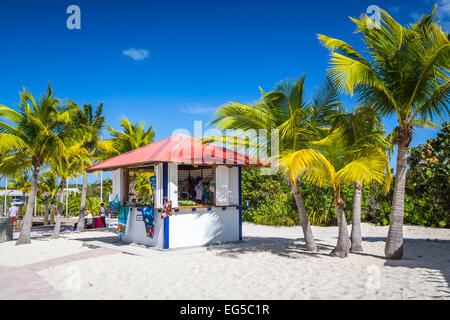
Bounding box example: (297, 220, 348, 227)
(0, 223, 450, 299)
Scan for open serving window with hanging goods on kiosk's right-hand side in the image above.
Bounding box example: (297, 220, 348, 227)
(178, 165, 216, 206)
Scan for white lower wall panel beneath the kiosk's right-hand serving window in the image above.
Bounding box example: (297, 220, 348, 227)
(169, 207, 239, 248)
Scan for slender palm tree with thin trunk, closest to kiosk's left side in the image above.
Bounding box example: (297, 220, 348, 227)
(70, 102, 105, 231)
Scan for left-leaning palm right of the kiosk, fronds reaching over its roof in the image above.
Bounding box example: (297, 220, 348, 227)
(210, 74, 340, 251)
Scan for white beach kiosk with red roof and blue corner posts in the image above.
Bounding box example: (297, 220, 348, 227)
(86, 134, 262, 249)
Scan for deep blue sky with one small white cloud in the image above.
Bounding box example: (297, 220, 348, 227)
(0, 0, 450, 184)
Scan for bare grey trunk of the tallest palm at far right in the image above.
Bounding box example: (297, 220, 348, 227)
(384, 141, 409, 259)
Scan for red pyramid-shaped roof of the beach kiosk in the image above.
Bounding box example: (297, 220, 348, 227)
(86, 134, 264, 172)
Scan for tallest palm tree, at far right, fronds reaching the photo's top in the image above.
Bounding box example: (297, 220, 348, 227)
(319, 5, 450, 259)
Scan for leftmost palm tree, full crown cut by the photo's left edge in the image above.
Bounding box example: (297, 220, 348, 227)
(0, 83, 71, 245)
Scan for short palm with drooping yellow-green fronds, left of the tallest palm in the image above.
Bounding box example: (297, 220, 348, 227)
(280, 128, 386, 258)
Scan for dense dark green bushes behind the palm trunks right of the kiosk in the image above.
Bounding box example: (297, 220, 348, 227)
(242, 122, 450, 228)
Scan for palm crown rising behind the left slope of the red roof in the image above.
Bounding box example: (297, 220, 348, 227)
(103, 117, 155, 201)
